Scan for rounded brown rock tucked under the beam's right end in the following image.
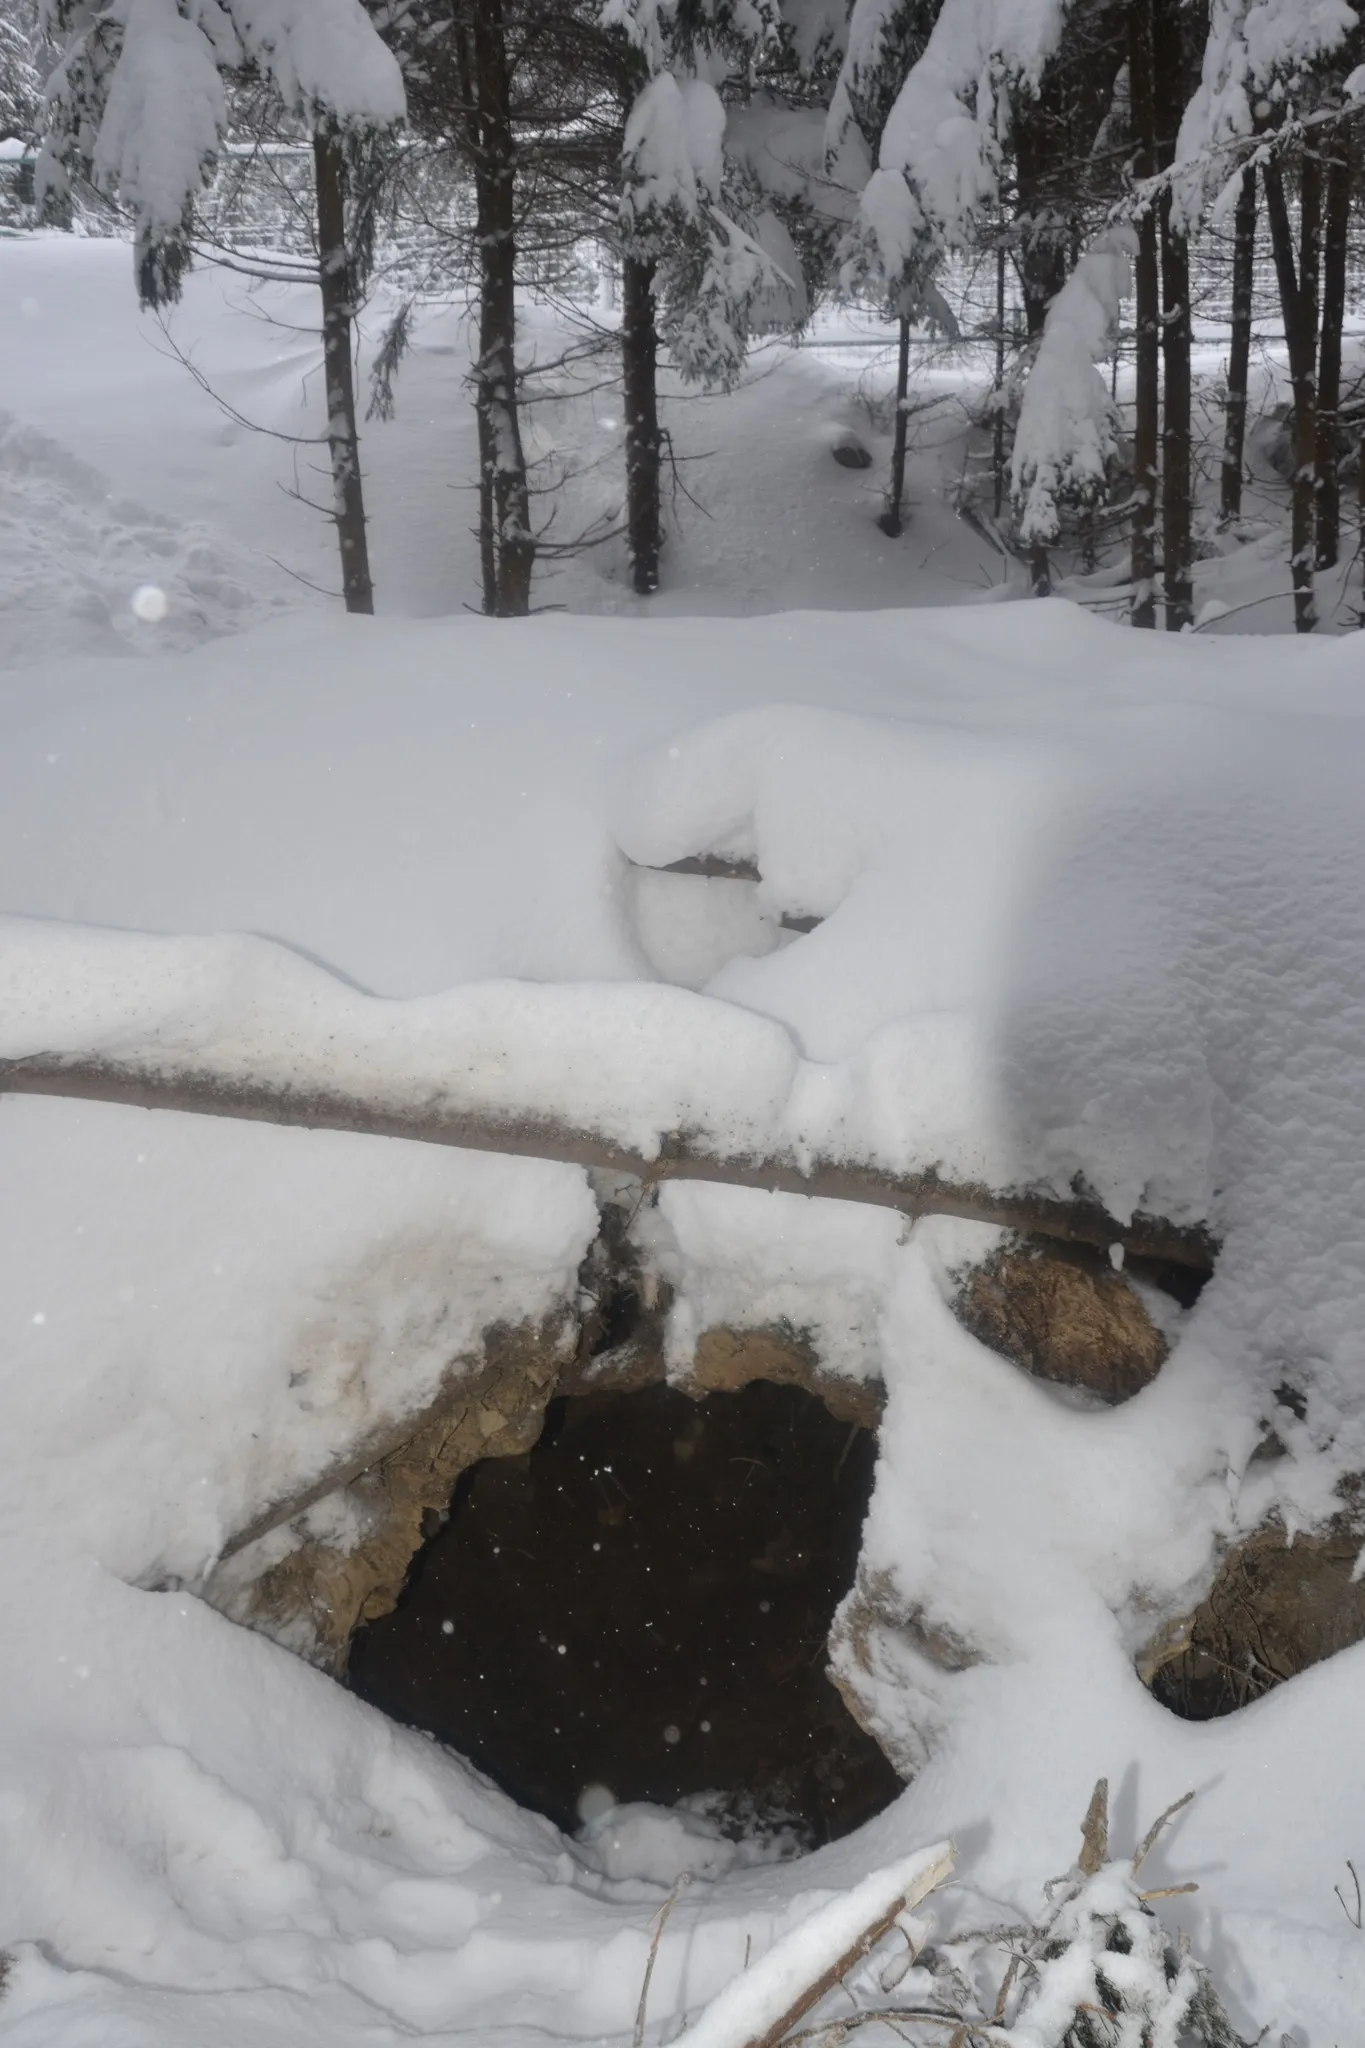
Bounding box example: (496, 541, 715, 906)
(954, 1243, 1166, 1403)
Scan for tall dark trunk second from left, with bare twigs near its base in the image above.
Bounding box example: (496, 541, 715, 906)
(471, 0, 536, 618)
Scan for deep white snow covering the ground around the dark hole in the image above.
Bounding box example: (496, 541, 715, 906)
(0, 238, 1365, 2048)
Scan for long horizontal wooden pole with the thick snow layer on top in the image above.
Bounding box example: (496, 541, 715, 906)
(0, 918, 1214, 1270)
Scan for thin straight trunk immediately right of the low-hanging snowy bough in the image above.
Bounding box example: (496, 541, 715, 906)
(1128, 0, 1160, 627)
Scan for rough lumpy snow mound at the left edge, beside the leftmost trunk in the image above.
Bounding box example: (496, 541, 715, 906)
(0, 414, 289, 668)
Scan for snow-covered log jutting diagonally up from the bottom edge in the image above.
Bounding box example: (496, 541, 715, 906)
(673, 1841, 954, 2048)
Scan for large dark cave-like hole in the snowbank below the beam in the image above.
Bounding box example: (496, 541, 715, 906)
(350, 1380, 900, 1845)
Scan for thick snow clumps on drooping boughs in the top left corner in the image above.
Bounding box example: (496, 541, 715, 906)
(39, 0, 405, 305)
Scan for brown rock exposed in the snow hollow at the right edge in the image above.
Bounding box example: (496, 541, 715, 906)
(1138, 1489, 1365, 1720)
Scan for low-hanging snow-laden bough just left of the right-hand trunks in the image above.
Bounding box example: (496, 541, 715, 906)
(1011, 229, 1134, 543)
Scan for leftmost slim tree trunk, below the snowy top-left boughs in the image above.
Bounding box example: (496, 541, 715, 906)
(313, 129, 375, 612)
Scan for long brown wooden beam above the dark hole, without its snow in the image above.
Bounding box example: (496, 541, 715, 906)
(0, 1055, 1218, 1274)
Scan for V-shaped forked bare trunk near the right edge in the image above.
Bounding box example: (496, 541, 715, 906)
(1265, 152, 1322, 633)
